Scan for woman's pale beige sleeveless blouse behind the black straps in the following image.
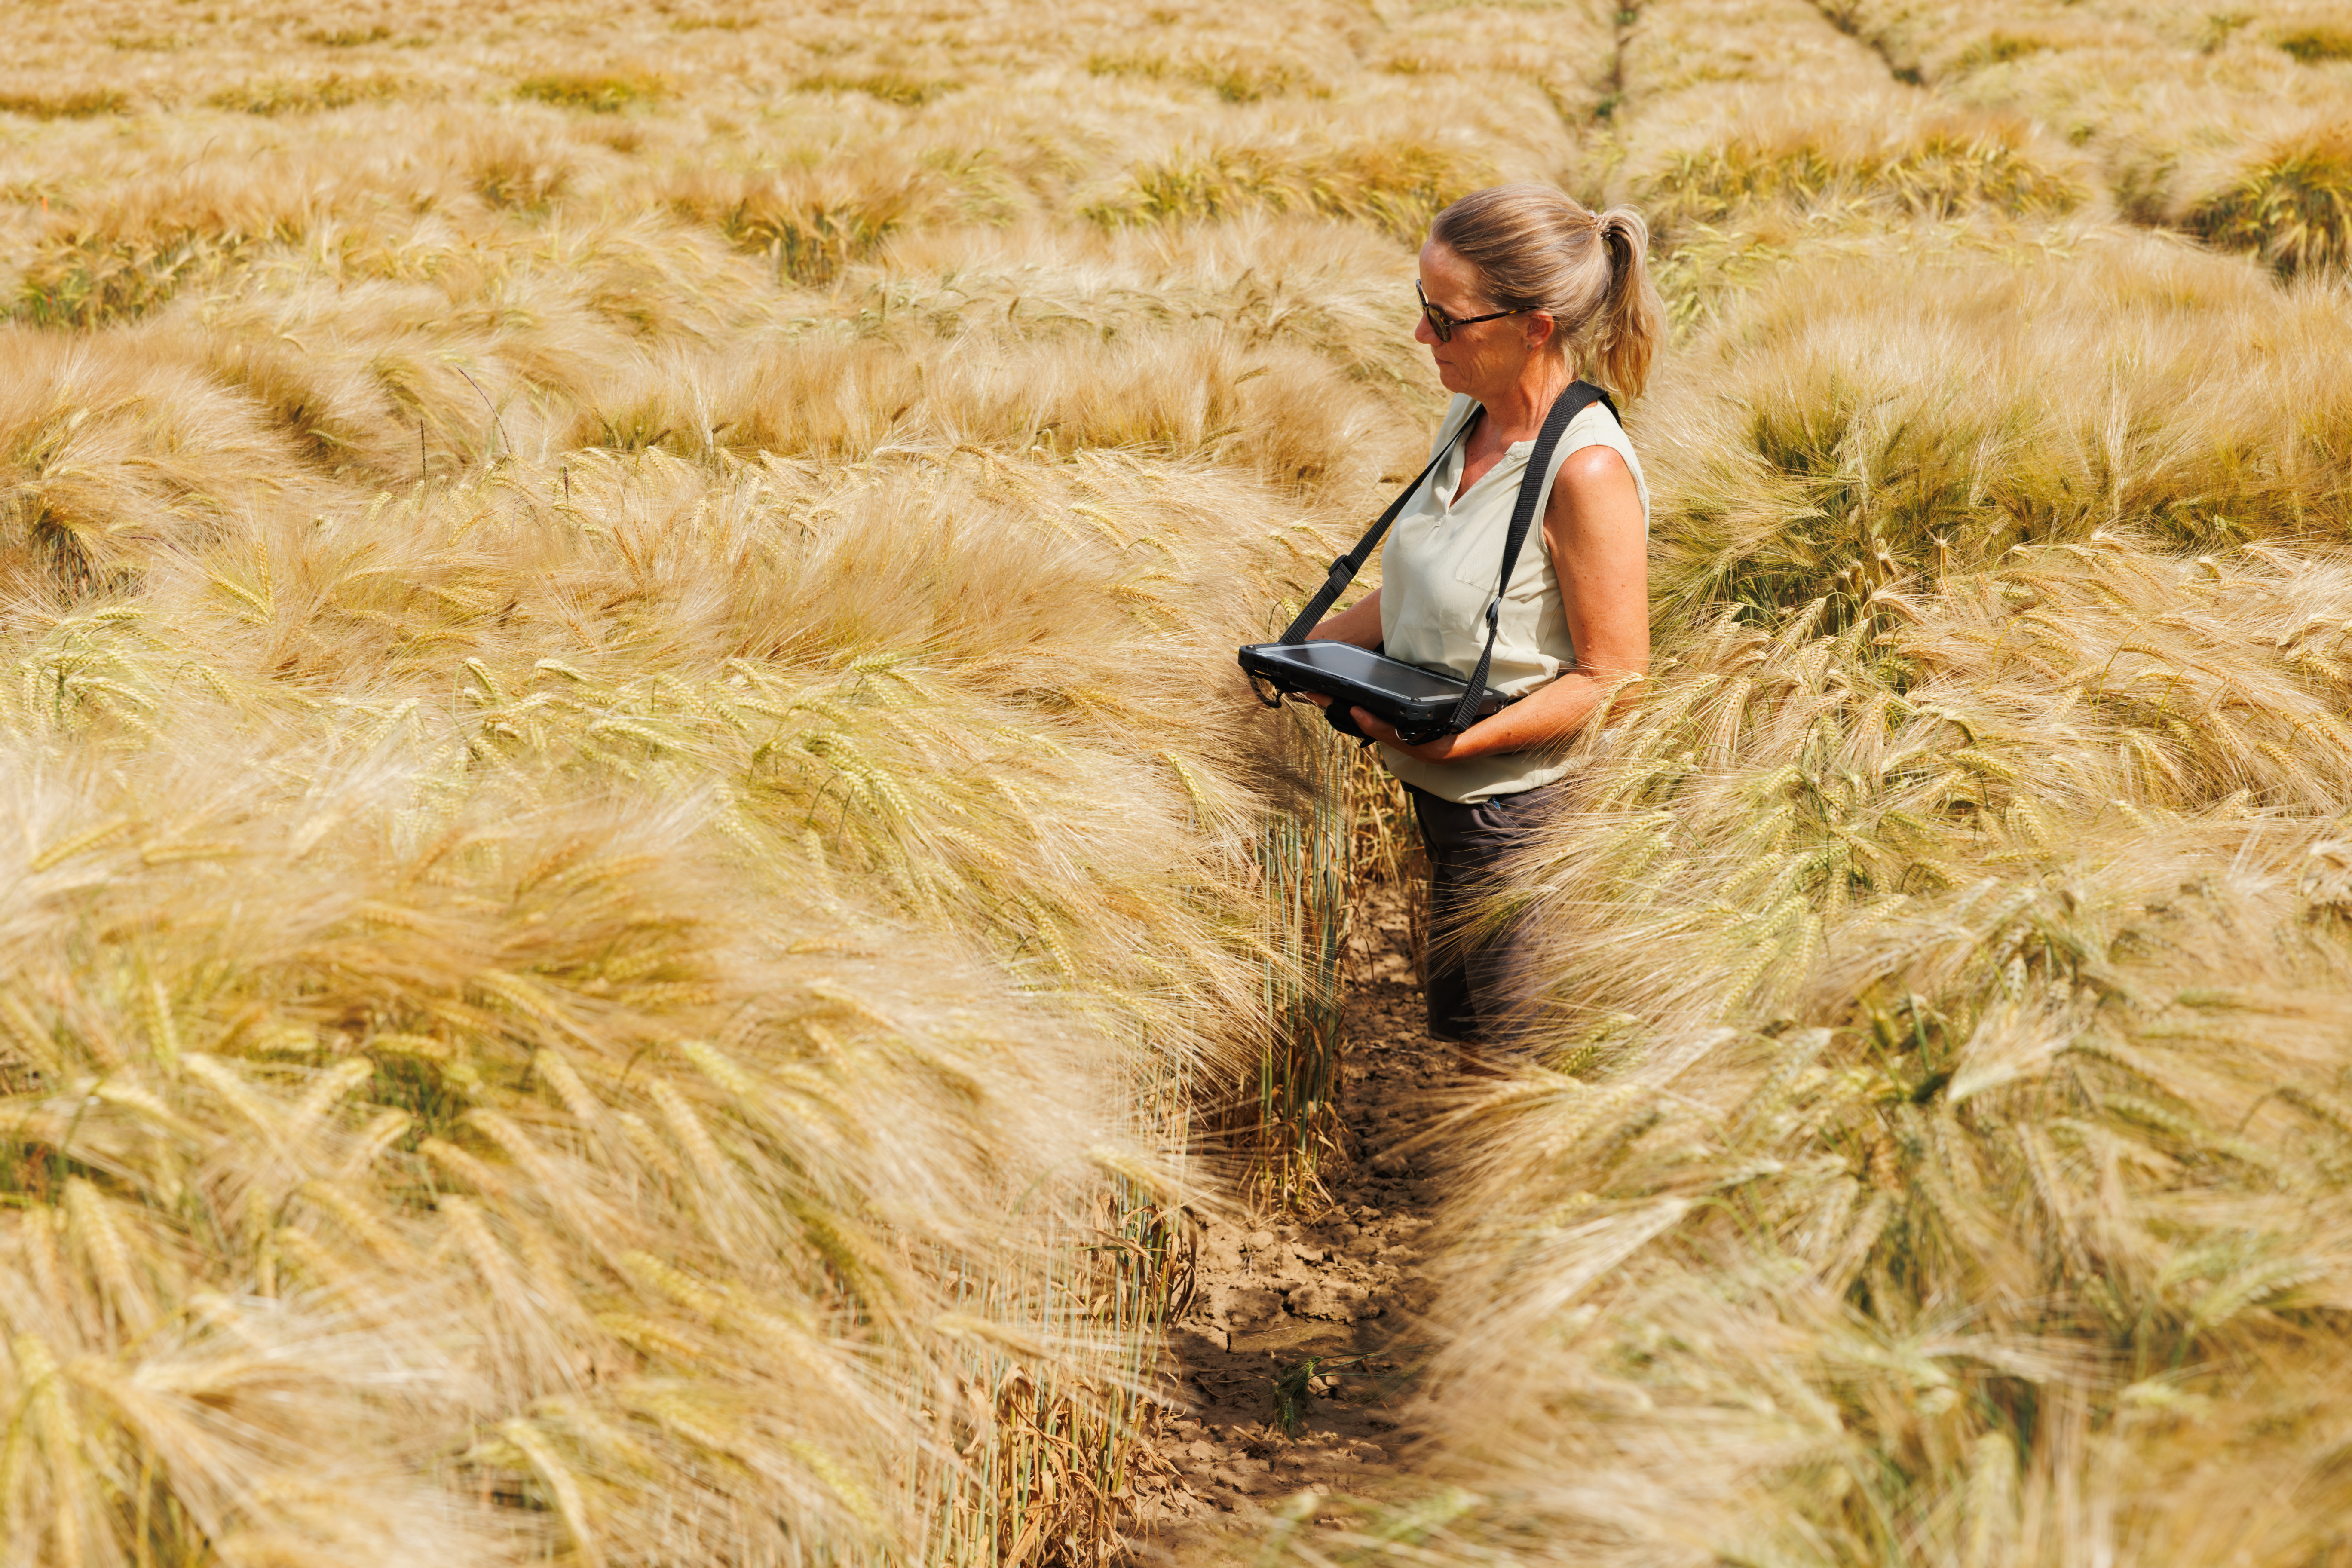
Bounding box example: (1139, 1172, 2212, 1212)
(1381, 395, 1649, 804)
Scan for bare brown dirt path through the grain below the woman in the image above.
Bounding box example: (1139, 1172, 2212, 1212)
(1131, 891, 1461, 1563)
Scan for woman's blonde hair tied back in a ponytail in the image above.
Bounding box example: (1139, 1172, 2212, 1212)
(1430, 186, 1665, 397)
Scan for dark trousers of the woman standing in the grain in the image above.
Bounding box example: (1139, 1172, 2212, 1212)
(1404, 785, 1559, 1046)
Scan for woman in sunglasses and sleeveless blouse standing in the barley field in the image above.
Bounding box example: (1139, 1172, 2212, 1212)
(1312, 186, 1660, 1046)
